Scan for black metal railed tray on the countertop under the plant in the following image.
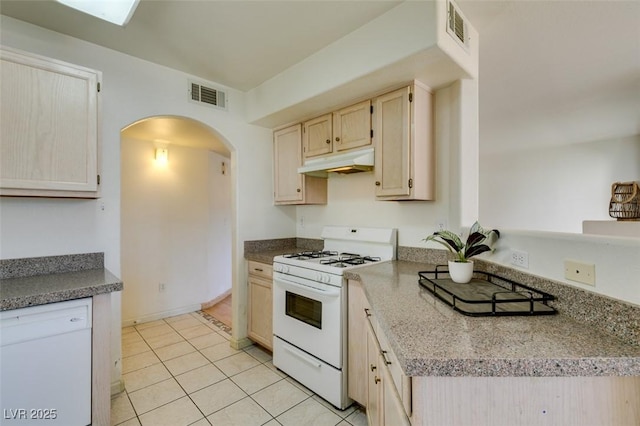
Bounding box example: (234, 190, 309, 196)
(418, 265, 557, 316)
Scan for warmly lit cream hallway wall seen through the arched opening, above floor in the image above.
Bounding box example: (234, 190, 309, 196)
(120, 116, 232, 324)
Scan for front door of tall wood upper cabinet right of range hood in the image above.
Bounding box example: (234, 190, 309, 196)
(373, 87, 411, 197)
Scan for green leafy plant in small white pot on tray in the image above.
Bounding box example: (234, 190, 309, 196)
(424, 221, 500, 283)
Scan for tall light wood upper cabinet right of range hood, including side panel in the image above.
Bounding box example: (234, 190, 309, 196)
(373, 83, 435, 200)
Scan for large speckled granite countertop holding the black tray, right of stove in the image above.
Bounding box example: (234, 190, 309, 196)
(345, 261, 640, 377)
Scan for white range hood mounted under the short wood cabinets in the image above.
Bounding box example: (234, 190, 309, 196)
(298, 148, 374, 177)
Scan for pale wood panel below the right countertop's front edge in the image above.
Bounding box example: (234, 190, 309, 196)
(412, 376, 640, 426)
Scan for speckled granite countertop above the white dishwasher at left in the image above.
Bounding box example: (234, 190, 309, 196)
(0, 268, 123, 311)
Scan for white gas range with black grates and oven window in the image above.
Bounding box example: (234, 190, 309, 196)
(273, 226, 397, 409)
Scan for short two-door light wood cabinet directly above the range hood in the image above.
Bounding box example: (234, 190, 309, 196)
(303, 100, 371, 158)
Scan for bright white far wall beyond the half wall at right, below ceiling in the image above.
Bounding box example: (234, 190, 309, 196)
(480, 135, 640, 233)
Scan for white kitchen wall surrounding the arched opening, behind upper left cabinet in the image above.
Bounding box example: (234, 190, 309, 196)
(0, 16, 295, 392)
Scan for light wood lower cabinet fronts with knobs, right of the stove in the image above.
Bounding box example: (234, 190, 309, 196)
(347, 280, 411, 426)
